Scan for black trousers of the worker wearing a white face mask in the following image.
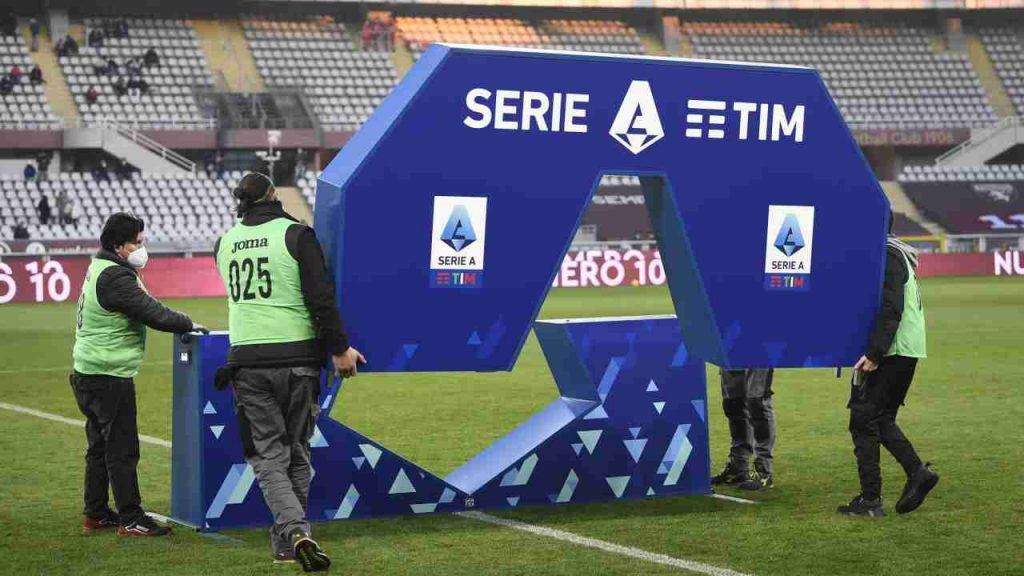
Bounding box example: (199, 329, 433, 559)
(71, 373, 143, 524)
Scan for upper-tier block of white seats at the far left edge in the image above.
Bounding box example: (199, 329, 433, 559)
(0, 29, 61, 129)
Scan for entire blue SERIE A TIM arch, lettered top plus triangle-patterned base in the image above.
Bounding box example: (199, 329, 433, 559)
(172, 45, 888, 530)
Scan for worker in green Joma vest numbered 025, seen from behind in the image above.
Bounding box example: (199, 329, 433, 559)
(214, 172, 366, 572)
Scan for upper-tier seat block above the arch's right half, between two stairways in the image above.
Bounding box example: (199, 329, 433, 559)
(683, 22, 996, 128)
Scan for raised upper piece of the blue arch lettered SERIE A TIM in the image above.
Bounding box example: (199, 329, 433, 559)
(315, 45, 889, 371)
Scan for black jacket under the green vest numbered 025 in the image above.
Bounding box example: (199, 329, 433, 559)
(213, 202, 348, 367)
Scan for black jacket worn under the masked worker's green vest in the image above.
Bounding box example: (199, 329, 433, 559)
(96, 250, 193, 334)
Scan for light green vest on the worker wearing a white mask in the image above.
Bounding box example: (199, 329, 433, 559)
(74, 258, 145, 378)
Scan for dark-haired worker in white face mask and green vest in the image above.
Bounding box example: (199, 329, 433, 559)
(71, 212, 209, 536)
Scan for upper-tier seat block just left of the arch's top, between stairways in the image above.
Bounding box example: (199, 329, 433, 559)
(243, 18, 398, 131)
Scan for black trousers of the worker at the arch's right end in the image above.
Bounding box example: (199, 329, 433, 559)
(848, 356, 922, 499)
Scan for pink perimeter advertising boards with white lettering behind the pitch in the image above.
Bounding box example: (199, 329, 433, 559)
(0, 250, 1024, 304)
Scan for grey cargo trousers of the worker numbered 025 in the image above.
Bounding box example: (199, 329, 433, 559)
(232, 367, 319, 553)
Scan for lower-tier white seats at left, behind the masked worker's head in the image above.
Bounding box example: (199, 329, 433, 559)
(0, 172, 234, 241)
